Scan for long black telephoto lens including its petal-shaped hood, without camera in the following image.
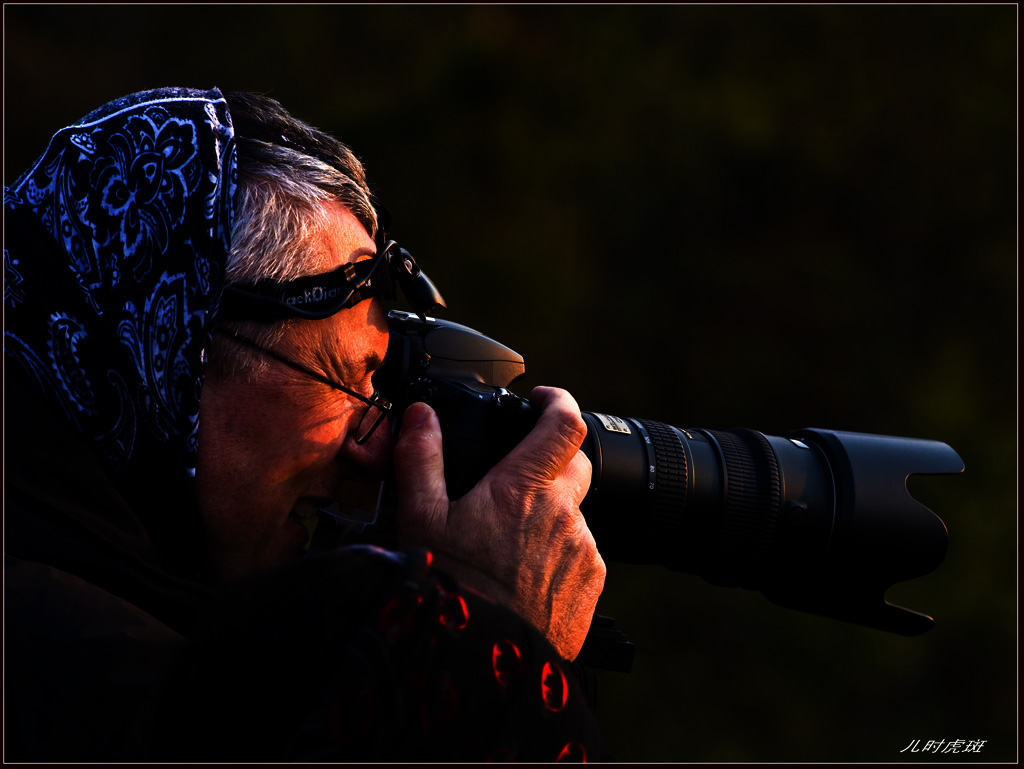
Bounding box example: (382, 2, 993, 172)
(581, 412, 963, 635)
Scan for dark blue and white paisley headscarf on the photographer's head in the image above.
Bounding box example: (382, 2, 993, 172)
(4, 88, 236, 474)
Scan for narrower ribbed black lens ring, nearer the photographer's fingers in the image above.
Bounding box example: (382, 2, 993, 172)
(636, 419, 688, 547)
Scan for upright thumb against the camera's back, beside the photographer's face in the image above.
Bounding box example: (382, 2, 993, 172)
(394, 403, 449, 530)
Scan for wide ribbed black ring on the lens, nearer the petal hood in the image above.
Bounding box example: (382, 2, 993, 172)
(706, 429, 782, 589)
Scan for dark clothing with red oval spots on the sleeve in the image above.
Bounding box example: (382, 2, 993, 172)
(4, 370, 608, 762)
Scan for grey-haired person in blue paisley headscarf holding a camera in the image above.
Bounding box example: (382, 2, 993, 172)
(4, 89, 606, 762)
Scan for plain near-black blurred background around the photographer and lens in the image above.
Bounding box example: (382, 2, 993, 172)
(4, 5, 1018, 762)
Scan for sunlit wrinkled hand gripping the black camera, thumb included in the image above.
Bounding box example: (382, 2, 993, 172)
(394, 387, 605, 659)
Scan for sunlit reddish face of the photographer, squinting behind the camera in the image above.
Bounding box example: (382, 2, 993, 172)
(196, 204, 392, 579)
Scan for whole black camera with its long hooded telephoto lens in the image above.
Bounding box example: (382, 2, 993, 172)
(374, 311, 964, 635)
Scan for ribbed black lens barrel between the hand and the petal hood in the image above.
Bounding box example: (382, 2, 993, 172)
(582, 413, 798, 589)
